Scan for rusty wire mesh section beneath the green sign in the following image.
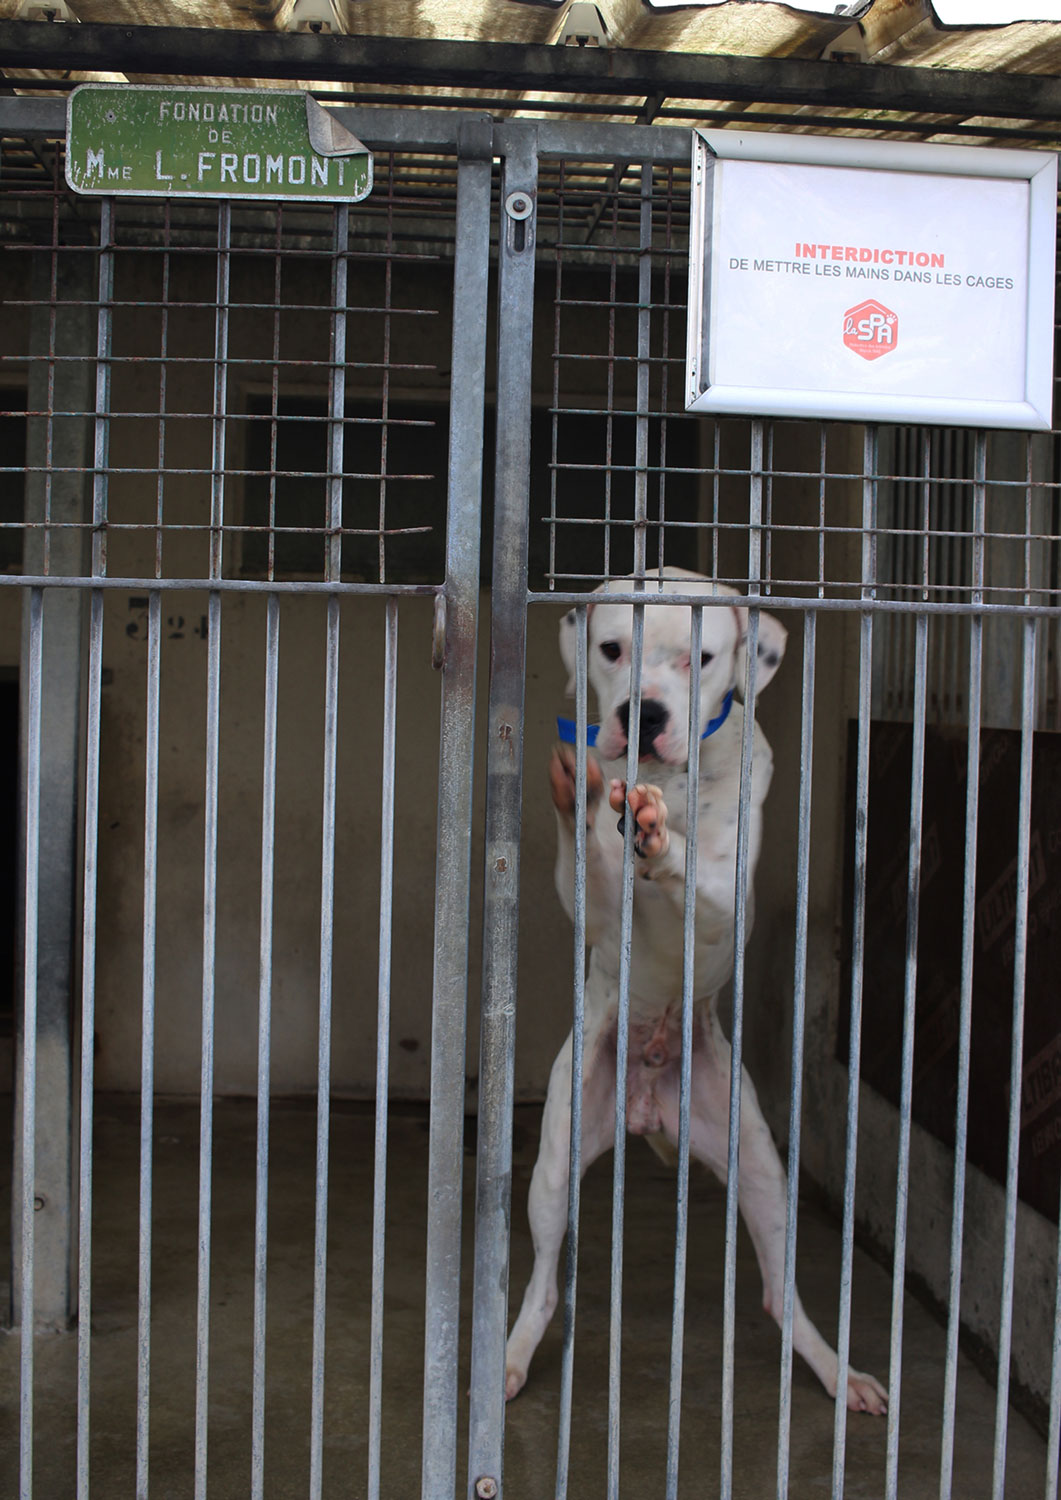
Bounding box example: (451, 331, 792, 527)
(0, 143, 455, 585)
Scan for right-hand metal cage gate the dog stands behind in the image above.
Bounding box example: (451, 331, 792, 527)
(468, 123, 1058, 1497)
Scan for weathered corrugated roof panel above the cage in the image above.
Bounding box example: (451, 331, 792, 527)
(0, 0, 1061, 123)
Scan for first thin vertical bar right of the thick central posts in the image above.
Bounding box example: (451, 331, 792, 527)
(555, 605, 590, 1500)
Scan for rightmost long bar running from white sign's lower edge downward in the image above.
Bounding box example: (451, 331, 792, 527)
(939, 431, 987, 1500)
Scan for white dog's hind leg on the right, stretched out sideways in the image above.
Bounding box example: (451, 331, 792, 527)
(663, 1011, 888, 1416)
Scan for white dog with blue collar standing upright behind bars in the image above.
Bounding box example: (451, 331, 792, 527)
(506, 569, 887, 1413)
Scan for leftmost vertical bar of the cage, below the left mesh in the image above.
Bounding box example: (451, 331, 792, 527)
(18, 588, 44, 1500)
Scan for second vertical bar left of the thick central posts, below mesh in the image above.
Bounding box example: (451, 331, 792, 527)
(309, 596, 339, 1500)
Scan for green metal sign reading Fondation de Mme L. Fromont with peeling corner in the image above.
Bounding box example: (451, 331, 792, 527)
(66, 84, 372, 203)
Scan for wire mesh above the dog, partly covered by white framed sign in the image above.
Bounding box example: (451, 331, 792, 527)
(536, 153, 1061, 609)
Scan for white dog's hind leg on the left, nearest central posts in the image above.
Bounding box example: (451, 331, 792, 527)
(504, 1037, 615, 1401)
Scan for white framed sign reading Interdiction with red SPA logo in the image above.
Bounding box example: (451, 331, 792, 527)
(686, 131, 1056, 429)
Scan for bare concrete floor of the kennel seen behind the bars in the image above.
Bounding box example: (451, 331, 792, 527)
(0, 1097, 1044, 1500)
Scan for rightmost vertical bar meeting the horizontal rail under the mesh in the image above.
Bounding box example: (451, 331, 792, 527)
(992, 612, 1037, 1500)
